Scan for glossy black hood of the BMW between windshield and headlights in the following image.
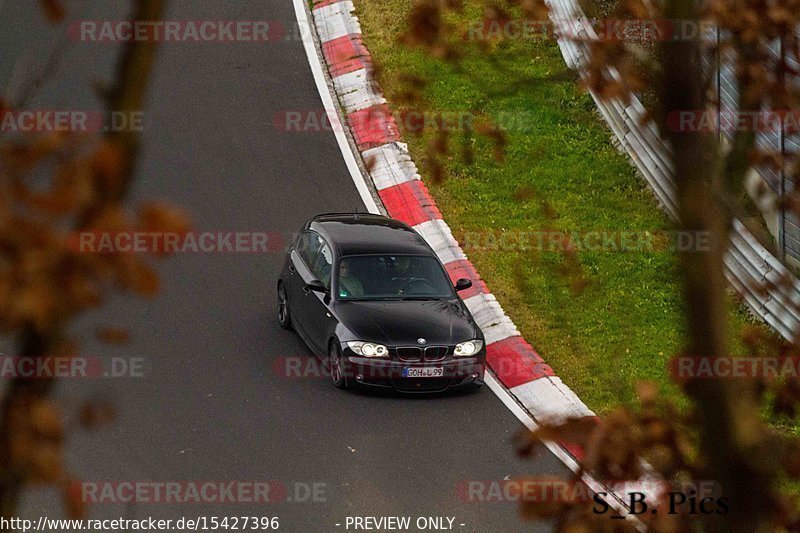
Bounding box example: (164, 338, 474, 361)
(336, 299, 479, 346)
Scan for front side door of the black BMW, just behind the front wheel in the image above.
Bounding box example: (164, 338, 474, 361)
(303, 239, 336, 355)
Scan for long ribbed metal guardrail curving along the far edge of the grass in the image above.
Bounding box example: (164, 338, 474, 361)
(546, 0, 800, 341)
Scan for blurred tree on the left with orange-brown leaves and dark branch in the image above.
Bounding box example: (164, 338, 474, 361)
(0, 0, 188, 517)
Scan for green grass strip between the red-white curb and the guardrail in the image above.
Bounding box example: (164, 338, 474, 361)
(356, 0, 768, 414)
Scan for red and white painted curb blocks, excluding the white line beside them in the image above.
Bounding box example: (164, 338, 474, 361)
(312, 0, 595, 459)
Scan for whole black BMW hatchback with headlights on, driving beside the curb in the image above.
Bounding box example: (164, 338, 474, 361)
(278, 213, 486, 392)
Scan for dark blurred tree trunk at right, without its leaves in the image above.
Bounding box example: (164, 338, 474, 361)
(658, 0, 776, 532)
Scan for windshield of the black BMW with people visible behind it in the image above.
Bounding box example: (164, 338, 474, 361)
(336, 255, 453, 300)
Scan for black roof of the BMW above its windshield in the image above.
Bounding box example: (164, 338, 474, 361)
(306, 213, 435, 256)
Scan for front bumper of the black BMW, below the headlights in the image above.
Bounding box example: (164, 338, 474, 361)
(342, 350, 486, 393)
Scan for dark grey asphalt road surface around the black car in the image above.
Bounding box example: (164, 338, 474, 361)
(0, 0, 566, 531)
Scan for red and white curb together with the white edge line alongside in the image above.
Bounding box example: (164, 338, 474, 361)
(293, 0, 642, 529)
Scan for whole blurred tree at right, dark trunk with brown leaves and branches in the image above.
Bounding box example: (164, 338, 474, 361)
(401, 0, 800, 532)
